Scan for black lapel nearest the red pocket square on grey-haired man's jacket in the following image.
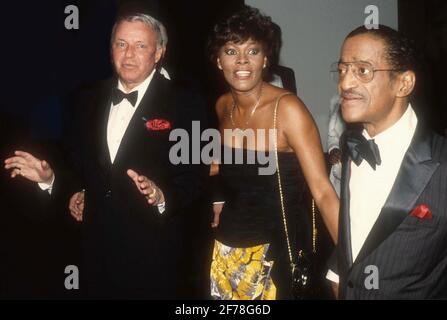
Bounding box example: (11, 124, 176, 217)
(114, 72, 164, 164)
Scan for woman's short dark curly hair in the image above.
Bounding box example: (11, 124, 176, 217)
(208, 6, 276, 69)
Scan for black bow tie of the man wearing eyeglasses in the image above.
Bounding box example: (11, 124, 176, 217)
(345, 130, 382, 170)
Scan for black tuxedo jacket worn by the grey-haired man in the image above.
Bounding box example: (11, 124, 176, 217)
(54, 73, 206, 299)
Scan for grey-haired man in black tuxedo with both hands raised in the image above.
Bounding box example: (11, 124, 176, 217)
(7, 13, 206, 299)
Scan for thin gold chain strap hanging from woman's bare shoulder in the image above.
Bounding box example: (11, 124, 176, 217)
(273, 92, 317, 274)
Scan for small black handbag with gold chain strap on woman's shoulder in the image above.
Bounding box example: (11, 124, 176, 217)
(273, 92, 317, 300)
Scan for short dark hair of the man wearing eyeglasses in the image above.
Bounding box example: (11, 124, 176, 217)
(346, 24, 417, 72)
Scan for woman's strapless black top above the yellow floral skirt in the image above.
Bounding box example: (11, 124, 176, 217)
(216, 147, 310, 299)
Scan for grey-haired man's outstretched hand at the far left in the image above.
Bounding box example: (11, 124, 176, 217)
(5, 151, 54, 184)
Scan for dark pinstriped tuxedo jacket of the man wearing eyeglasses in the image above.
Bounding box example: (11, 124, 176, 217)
(336, 126, 447, 299)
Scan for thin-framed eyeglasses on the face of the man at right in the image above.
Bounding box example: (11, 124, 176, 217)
(331, 61, 404, 83)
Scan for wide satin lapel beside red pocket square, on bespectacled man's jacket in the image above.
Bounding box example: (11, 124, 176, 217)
(355, 127, 439, 263)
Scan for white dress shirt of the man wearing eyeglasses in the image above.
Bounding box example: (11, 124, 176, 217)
(327, 105, 418, 282)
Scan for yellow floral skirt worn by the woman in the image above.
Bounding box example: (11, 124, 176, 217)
(211, 241, 276, 300)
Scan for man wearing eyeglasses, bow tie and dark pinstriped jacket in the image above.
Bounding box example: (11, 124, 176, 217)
(327, 25, 447, 299)
